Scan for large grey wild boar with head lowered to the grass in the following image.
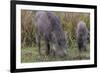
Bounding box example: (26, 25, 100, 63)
(35, 11, 67, 56)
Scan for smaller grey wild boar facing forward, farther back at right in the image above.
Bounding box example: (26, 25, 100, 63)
(76, 21, 88, 51)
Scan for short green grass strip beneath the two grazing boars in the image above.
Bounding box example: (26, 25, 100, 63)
(21, 44, 90, 63)
